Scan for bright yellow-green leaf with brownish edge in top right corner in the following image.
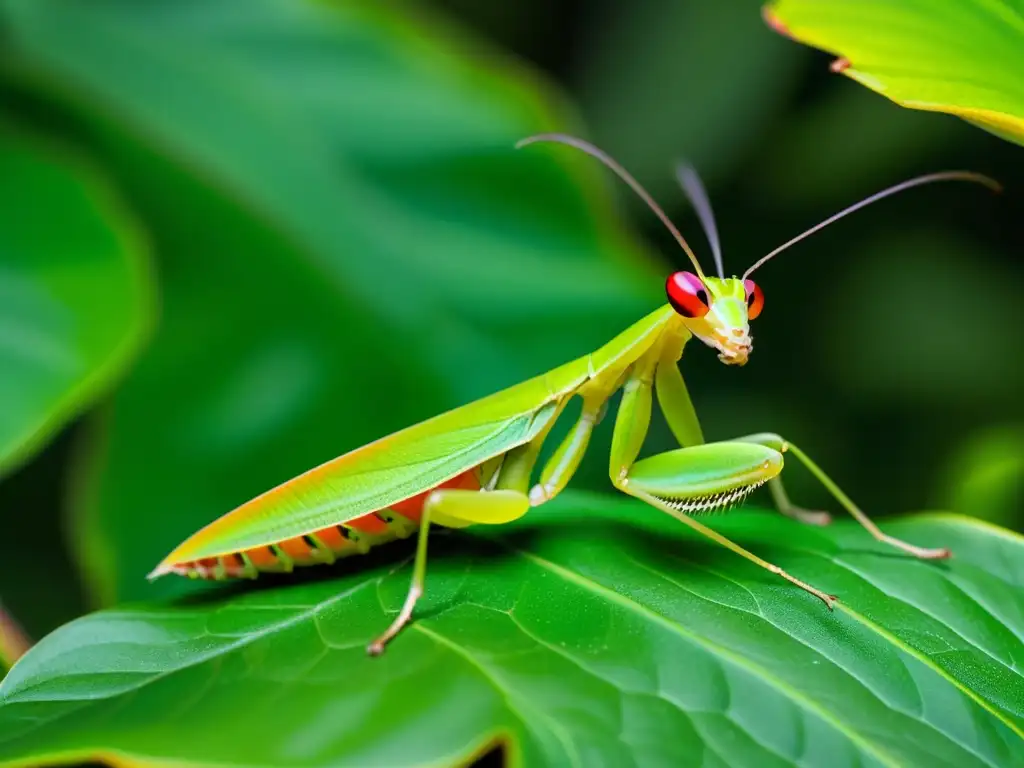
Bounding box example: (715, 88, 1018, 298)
(765, 0, 1024, 143)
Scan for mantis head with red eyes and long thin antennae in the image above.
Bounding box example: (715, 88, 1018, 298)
(516, 133, 1001, 366)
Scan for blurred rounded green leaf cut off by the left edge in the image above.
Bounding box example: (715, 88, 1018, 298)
(0, 127, 151, 475)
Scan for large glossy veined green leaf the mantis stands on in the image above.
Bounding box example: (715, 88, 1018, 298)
(0, 493, 1024, 768)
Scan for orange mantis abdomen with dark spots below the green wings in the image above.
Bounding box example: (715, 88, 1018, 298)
(169, 467, 480, 581)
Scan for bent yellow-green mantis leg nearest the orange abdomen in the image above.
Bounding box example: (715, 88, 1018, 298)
(367, 488, 529, 656)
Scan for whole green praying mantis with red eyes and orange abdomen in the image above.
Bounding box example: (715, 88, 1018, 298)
(148, 133, 1000, 655)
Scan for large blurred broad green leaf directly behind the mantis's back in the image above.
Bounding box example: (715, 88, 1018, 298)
(0, 0, 662, 599)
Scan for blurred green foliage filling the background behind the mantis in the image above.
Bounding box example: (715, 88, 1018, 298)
(0, 0, 1024, 765)
